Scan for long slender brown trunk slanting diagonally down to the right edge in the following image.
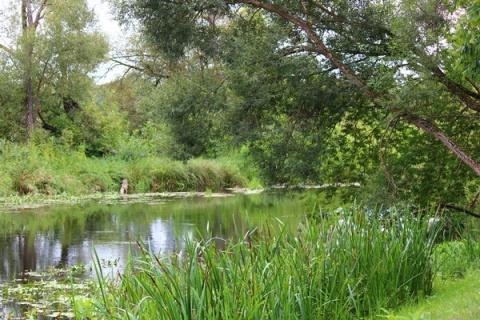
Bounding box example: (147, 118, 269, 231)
(239, 0, 480, 176)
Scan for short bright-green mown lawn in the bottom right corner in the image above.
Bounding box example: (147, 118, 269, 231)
(375, 270, 480, 320)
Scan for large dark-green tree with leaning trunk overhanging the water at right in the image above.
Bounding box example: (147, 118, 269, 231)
(109, 0, 480, 203)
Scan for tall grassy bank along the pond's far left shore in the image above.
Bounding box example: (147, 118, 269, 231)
(0, 141, 245, 196)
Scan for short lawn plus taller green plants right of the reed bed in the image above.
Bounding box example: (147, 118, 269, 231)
(378, 225, 480, 320)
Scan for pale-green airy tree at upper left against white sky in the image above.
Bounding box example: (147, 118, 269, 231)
(0, 0, 108, 140)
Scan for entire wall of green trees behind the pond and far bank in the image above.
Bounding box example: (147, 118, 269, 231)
(0, 0, 480, 206)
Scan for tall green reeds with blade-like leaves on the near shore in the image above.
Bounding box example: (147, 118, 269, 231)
(77, 209, 435, 319)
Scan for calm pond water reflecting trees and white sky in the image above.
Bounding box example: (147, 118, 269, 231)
(0, 193, 304, 282)
